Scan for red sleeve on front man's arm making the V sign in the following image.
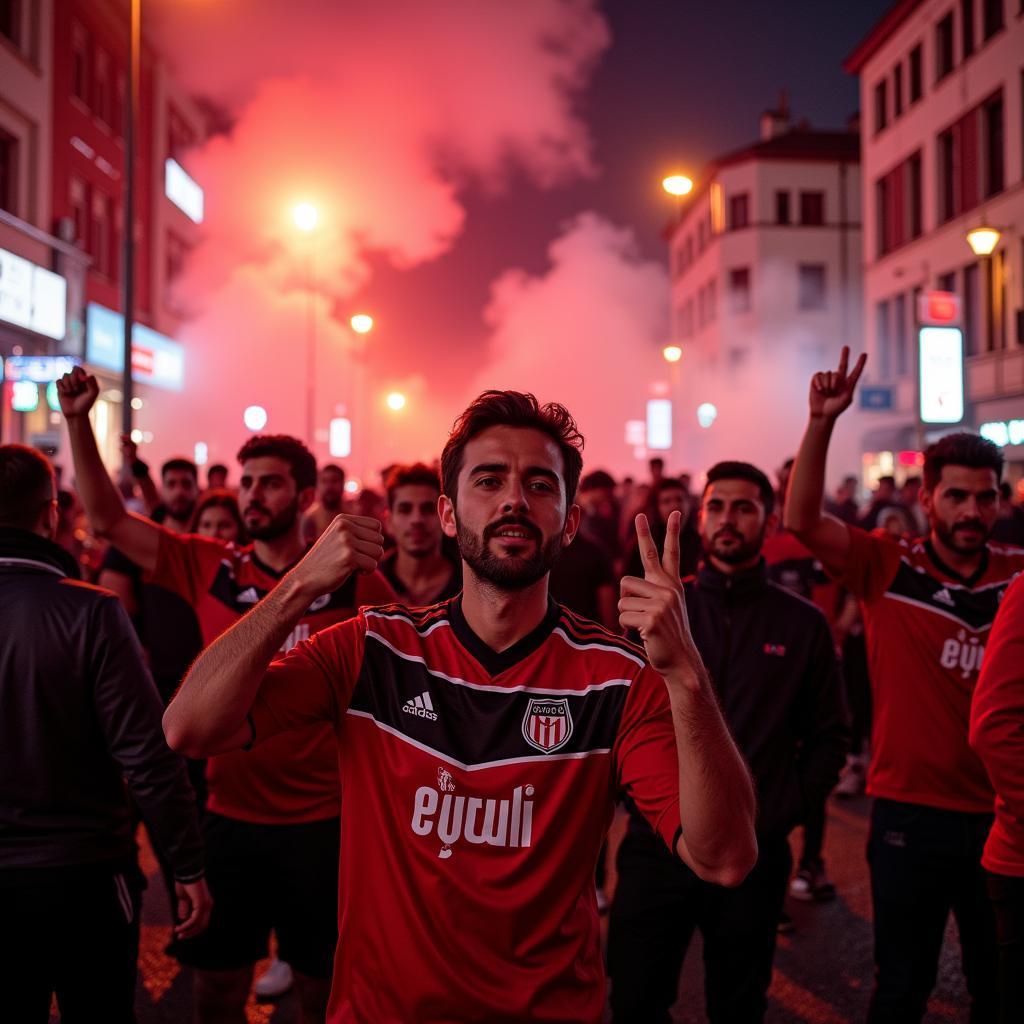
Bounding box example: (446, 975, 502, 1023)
(614, 668, 680, 853)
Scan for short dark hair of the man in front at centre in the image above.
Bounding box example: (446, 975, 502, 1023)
(441, 391, 584, 504)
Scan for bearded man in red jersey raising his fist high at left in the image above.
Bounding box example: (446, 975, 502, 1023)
(57, 369, 393, 1024)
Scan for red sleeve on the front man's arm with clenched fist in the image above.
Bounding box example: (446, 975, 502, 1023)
(250, 614, 367, 743)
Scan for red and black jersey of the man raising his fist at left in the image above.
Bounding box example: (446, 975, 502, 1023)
(146, 530, 394, 824)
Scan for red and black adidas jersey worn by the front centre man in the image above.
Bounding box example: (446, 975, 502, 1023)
(246, 597, 680, 1024)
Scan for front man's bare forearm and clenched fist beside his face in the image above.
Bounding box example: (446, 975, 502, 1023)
(164, 515, 384, 758)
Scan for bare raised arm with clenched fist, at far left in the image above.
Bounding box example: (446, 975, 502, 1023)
(57, 367, 161, 572)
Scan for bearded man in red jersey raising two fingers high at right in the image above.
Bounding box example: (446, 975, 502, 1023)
(785, 347, 1024, 1024)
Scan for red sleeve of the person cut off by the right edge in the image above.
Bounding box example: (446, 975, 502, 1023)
(971, 575, 1024, 818)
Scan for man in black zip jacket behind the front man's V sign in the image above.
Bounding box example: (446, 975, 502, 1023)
(608, 462, 849, 1024)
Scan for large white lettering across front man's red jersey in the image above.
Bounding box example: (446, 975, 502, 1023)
(412, 769, 534, 860)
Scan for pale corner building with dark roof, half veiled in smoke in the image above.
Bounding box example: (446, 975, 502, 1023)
(670, 97, 861, 478)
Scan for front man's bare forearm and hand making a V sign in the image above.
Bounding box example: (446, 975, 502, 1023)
(618, 512, 758, 886)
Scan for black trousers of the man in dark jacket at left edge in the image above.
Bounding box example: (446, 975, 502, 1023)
(0, 862, 145, 1024)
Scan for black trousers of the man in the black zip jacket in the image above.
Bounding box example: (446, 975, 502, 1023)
(608, 833, 793, 1024)
